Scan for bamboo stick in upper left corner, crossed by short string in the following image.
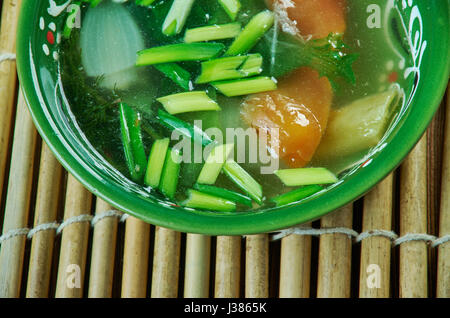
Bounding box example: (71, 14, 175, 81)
(0, 0, 22, 201)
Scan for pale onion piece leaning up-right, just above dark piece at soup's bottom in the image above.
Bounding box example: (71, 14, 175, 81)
(197, 144, 234, 184)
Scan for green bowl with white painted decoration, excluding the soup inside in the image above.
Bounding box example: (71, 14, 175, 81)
(17, 0, 450, 235)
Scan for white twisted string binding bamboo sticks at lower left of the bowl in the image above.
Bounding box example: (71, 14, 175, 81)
(0, 210, 129, 245)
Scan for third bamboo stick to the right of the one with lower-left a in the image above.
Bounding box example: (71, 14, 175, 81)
(151, 227, 181, 298)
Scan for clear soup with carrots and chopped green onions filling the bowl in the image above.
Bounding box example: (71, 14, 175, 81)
(60, 0, 411, 212)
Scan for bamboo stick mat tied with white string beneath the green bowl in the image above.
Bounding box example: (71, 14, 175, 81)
(0, 0, 450, 298)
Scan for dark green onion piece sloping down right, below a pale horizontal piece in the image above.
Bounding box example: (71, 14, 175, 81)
(158, 109, 213, 146)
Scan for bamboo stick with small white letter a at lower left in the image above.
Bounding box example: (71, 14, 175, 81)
(55, 175, 92, 298)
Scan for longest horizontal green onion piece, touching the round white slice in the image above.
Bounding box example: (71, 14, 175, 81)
(136, 43, 225, 66)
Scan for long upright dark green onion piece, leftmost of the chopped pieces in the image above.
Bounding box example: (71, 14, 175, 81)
(119, 103, 147, 182)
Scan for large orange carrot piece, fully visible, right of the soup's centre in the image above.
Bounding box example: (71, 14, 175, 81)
(241, 67, 333, 167)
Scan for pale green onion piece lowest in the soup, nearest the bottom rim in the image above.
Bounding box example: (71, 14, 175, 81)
(181, 190, 236, 212)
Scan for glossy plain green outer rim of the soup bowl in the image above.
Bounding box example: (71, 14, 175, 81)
(17, 0, 450, 235)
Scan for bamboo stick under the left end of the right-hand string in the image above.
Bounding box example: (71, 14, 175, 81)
(279, 225, 311, 298)
